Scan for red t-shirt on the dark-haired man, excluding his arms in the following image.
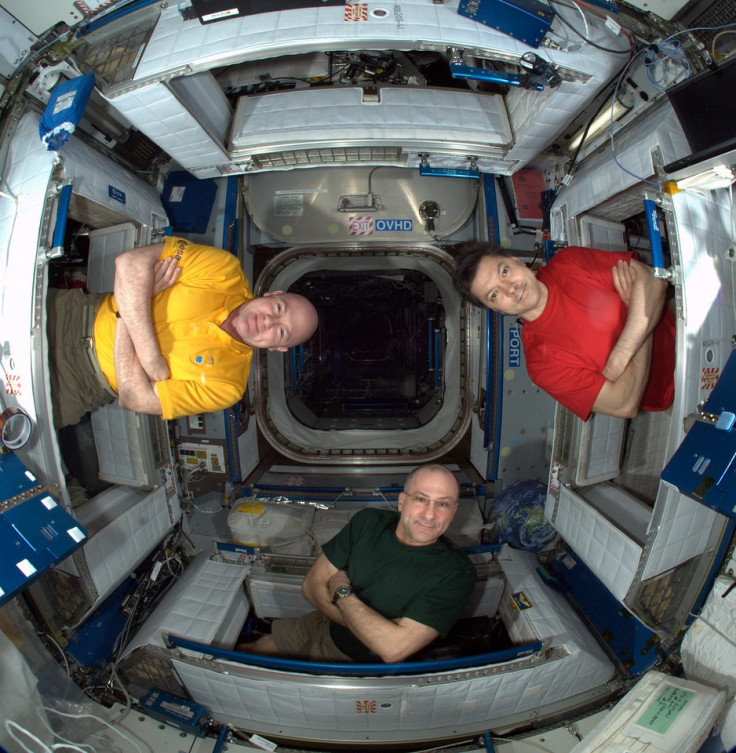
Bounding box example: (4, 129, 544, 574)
(521, 246, 675, 421)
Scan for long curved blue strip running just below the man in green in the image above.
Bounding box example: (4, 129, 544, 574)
(164, 635, 542, 677)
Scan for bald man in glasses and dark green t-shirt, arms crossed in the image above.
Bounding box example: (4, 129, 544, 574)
(239, 465, 476, 662)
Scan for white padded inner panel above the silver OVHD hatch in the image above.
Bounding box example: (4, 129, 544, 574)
(231, 87, 511, 154)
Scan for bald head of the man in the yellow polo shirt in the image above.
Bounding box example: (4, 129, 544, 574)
(222, 290, 317, 351)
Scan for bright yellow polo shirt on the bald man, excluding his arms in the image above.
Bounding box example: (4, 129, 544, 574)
(94, 237, 253, 419)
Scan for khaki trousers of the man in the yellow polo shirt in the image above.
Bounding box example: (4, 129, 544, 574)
(46, 288, 115, 429)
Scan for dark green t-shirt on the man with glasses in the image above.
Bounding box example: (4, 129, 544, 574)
(322, 509, 476, 662)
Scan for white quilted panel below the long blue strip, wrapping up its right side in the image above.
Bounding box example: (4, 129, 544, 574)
(173, 547, 614, 742)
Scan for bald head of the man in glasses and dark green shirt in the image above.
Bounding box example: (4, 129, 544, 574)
(396, 466, 459, 546)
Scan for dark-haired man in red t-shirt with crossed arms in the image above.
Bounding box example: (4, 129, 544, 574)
(454, 243, 675, 420)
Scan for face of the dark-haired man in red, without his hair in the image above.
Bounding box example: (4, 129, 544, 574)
(470, 256, 547, 321)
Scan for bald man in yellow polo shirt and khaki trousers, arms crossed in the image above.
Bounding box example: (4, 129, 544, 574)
(48, 238, 317, 428)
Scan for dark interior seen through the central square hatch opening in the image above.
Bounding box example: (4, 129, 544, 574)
(285, 270, 445, 429)
